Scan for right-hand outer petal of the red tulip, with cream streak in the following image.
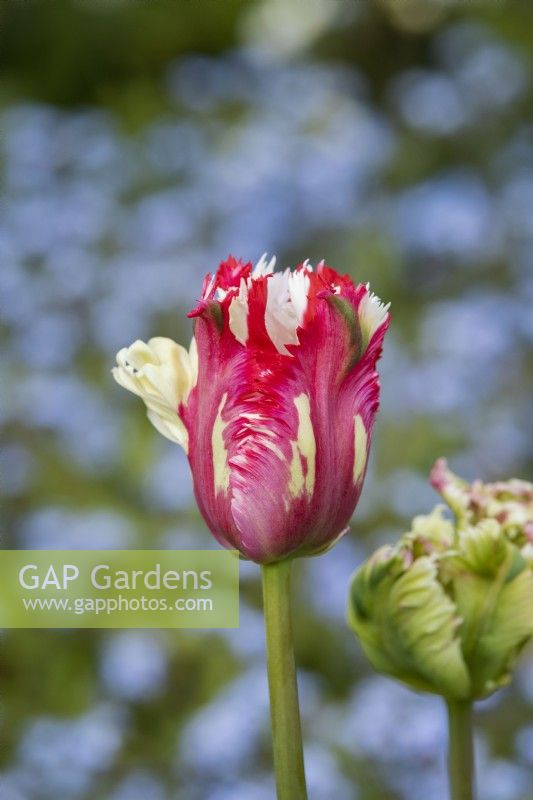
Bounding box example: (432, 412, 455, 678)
(254, 266, 388, 554)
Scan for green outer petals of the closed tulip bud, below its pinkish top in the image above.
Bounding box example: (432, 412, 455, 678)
(348, 495, 533, 700)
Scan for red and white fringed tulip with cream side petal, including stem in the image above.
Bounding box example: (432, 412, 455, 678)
(114, 256, 389, 800)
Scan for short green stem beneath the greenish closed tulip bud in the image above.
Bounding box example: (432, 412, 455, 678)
(447, 700, 474, 800)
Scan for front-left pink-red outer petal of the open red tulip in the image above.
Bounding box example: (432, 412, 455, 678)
(182, 280, 300, 561)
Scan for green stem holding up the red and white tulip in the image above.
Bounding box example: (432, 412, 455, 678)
(262, 560, 307, 800)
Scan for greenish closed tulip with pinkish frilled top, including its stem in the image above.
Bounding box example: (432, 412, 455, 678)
(348, 466, 533, 800)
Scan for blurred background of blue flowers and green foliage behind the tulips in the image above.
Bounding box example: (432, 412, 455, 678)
(0, 0, 533, 800)
